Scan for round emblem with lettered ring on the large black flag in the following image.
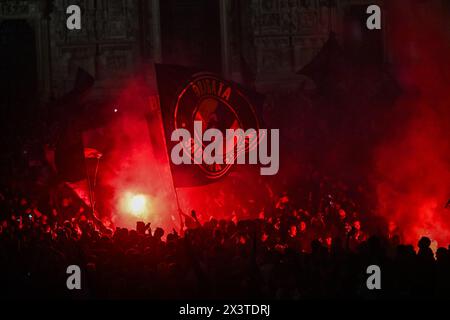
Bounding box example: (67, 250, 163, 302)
(174, 73, 259, 179)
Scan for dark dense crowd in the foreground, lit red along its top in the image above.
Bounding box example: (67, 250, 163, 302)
(0, 185, 450, 299)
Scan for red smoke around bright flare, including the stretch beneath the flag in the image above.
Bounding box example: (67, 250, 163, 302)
(85, 78, 265, 230)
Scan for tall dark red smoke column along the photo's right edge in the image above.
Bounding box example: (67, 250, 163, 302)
(375, 1, 450, 246)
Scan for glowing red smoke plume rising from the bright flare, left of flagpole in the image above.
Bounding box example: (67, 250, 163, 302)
(85, 77, 178, 227)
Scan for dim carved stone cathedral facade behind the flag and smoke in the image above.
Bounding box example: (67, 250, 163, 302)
(0, 0, 400, 103)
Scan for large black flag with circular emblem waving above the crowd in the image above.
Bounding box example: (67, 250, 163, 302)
(155, 64, 263, 187)
